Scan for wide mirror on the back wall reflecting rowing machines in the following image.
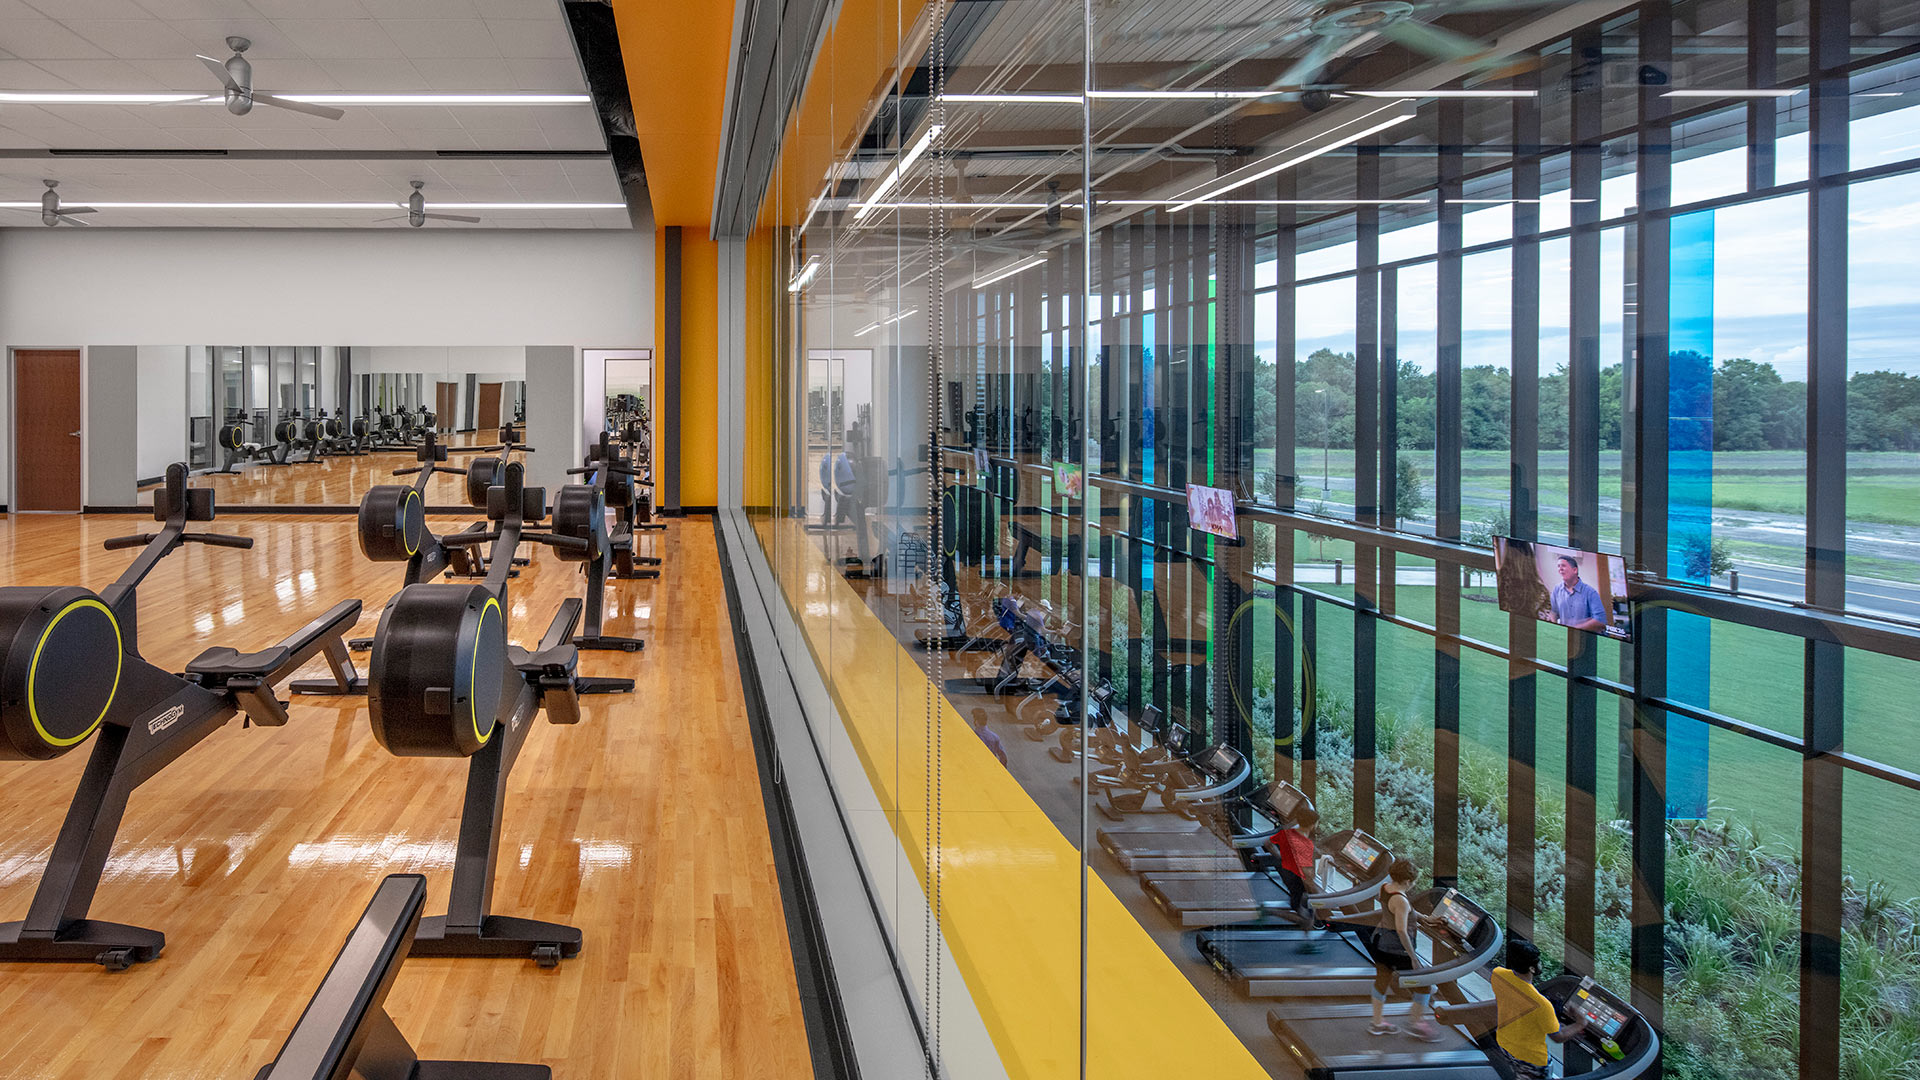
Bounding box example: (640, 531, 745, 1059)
(156, 344, 526, 505)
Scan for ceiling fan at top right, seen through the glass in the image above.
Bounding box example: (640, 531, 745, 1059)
(1140, 0, 1549, 90)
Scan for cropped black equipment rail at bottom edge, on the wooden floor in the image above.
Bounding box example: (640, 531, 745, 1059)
(253, 874, 553, 1080)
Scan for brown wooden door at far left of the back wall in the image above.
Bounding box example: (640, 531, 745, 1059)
(13, 348, 81, 513)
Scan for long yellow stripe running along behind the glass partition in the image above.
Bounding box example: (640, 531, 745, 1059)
(755, 519, 1267, 1080)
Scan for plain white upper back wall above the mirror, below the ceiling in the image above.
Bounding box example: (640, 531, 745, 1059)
(0, 229, 655, 345)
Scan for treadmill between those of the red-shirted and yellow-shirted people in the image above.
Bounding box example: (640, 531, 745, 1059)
(1196, 880, 1505, 999)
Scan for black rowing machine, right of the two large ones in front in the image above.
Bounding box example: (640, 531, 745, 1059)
(367, 461, 595, 967)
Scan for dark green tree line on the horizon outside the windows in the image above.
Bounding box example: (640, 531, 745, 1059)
(1254, 348, 1920, 452)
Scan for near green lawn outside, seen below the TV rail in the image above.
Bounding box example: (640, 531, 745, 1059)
(1254, 586, 1920, 897)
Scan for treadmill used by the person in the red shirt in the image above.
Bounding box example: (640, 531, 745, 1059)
(1140, 782, 1394, 928)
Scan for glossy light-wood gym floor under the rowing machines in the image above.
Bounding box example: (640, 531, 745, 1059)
(0, 507, 810, 1080)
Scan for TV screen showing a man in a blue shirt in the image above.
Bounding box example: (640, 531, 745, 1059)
(1494, 536, 1632, 642)
